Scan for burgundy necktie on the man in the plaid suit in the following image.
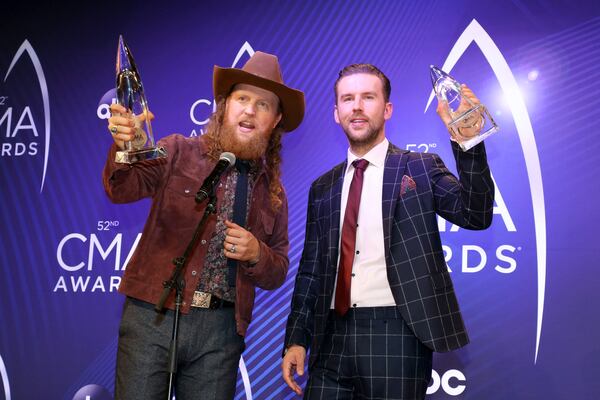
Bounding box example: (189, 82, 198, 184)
(335, 159, 369, 316)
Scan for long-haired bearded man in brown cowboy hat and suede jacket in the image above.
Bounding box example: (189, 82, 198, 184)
(103, 52, 304, 399)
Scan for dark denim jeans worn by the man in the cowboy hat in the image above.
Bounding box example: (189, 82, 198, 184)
(115, 298, 244, 400)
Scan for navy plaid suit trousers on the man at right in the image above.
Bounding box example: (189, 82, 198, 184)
(305, 307, 432, 400)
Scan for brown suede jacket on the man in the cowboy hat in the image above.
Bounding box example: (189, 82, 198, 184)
(103, 135, 289, 335)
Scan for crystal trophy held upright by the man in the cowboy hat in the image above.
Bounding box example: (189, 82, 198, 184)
(115, 36, 167, 164)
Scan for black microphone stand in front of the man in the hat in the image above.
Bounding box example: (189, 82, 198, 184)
(154, 190, 217, 400)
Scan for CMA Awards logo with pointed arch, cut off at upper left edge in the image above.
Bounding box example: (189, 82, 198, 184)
(0, 40, 50, 193)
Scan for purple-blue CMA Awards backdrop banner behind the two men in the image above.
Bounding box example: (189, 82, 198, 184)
(0, 0, 600, 400)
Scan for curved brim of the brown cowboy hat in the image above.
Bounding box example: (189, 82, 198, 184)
(213, 65, 305, 132)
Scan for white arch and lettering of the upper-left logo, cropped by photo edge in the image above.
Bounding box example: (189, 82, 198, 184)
(0, 39, 50, 193)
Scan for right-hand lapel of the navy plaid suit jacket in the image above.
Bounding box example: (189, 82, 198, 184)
(381, 143, 408, 253)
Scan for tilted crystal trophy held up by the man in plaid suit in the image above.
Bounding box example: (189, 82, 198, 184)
(430, 65, 499, 151)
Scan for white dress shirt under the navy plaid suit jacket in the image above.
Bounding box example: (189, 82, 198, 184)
(331, 139, 396, 308)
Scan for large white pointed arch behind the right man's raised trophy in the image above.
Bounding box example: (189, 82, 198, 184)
(425, 20, 546, 363)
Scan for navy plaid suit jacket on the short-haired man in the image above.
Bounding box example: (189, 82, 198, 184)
(285, 143, 494, 365)
